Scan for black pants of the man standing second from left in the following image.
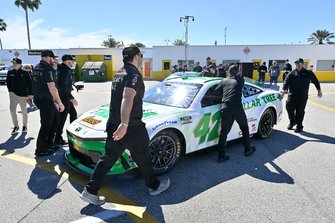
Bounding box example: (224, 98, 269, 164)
(34, 98, 58, 153)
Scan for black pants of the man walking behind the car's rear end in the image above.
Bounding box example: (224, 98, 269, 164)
(286, 96, 308, 129)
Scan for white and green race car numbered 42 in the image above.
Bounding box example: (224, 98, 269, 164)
(65, 77, 282, 175)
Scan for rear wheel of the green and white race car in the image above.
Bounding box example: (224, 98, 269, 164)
(256, 108, 276, 139)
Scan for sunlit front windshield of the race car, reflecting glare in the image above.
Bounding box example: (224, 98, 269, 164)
(143, 82, 202, 108)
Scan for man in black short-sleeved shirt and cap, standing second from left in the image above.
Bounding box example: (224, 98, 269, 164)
(32, 50, 64, 156)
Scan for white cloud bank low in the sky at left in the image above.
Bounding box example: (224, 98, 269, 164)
(0, 17, 146, 49)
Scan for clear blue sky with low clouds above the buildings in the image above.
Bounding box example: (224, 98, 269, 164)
(0, 0, 335, 49)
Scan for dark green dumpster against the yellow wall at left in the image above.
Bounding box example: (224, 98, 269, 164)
(81, 62, 107, 82)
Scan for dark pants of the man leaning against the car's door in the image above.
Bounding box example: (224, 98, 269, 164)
(218, 106, 250, 158)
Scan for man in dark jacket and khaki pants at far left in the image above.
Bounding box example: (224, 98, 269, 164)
(7, 58, 32, 135)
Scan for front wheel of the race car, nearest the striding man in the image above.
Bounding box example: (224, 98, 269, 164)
(149, 130, 182, 175)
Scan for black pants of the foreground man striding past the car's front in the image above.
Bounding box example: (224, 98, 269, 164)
(86, 124, 160, 194)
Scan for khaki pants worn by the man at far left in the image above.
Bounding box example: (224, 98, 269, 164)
(9, 92, 28, 127)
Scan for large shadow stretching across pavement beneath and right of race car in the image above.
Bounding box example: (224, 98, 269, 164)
(109, 130, 335, 222)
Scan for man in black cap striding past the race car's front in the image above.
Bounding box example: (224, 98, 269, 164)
(80, 47, 170, 205)
